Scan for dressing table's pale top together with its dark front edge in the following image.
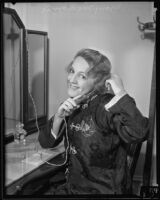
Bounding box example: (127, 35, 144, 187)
(4, 133, 64, 195)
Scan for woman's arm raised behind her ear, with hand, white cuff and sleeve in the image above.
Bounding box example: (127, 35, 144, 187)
(97, 75, 149, 143)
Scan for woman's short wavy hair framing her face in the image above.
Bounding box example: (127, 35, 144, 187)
(67, 48, 111, 93)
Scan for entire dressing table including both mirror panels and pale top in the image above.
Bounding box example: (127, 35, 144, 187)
(1, 7, 57, 195)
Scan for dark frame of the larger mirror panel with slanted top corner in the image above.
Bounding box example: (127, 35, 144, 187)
(2, 7, 27, 143)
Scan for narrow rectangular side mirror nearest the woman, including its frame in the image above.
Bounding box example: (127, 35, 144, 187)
(25, 30, 48, 132)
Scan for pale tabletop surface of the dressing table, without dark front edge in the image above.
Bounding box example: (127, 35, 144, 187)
(5, 133, 64, 186)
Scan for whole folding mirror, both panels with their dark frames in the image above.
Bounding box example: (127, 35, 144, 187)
(3, 8, 48, 143)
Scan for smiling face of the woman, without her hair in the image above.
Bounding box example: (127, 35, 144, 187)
(67, 56, 95, 97)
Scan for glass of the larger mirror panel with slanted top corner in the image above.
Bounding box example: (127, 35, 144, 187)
(3, 14, 21, 135)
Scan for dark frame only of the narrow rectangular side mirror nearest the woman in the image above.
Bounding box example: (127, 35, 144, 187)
(23, 30, 48, 134)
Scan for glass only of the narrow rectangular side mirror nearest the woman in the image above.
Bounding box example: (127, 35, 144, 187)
(27, 31, 45, 120)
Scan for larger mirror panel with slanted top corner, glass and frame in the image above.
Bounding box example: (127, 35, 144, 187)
(3, 8, 26, 142)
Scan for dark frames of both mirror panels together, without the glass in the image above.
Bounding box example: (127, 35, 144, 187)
(1, 7, 49, 144)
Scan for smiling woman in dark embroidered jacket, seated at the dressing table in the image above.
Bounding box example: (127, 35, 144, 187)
(39, 49, 148, 194)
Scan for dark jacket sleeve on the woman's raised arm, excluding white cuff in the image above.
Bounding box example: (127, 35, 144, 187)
(96, 94, 149, 143)
